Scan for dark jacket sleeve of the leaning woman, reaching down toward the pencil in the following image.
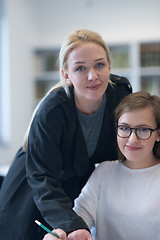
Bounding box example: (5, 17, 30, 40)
(26, 93, 88, 233)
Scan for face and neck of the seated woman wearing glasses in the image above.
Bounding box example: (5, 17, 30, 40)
(117, 107, 160, 168)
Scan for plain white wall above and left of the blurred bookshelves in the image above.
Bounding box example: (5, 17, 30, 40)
(0, 0, 160, 166)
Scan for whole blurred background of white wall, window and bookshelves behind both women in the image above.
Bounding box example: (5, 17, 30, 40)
(0, 0, 160, 173)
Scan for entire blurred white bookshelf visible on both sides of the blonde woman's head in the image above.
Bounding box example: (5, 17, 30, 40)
(33, 41, 160, 104)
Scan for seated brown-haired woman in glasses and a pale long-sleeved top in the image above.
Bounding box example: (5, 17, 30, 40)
(44, 92, 160, 240)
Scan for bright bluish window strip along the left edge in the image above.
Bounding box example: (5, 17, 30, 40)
(0, 0, 10, 145)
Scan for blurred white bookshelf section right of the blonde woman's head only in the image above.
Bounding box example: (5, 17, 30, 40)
(110, 41, 160, 96)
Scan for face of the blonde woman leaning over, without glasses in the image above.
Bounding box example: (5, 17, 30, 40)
(62, 42, 111, 111)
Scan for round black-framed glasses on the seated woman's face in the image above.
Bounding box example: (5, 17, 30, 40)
(116, 125, 157, 140)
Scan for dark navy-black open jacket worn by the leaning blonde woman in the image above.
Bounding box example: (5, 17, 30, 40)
(0, 75, 132, 240)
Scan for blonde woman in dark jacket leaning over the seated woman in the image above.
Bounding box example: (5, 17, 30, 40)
(0, 29, 132, 240)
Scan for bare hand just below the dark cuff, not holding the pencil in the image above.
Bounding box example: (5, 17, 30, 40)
(67, 229, 94, 240)
